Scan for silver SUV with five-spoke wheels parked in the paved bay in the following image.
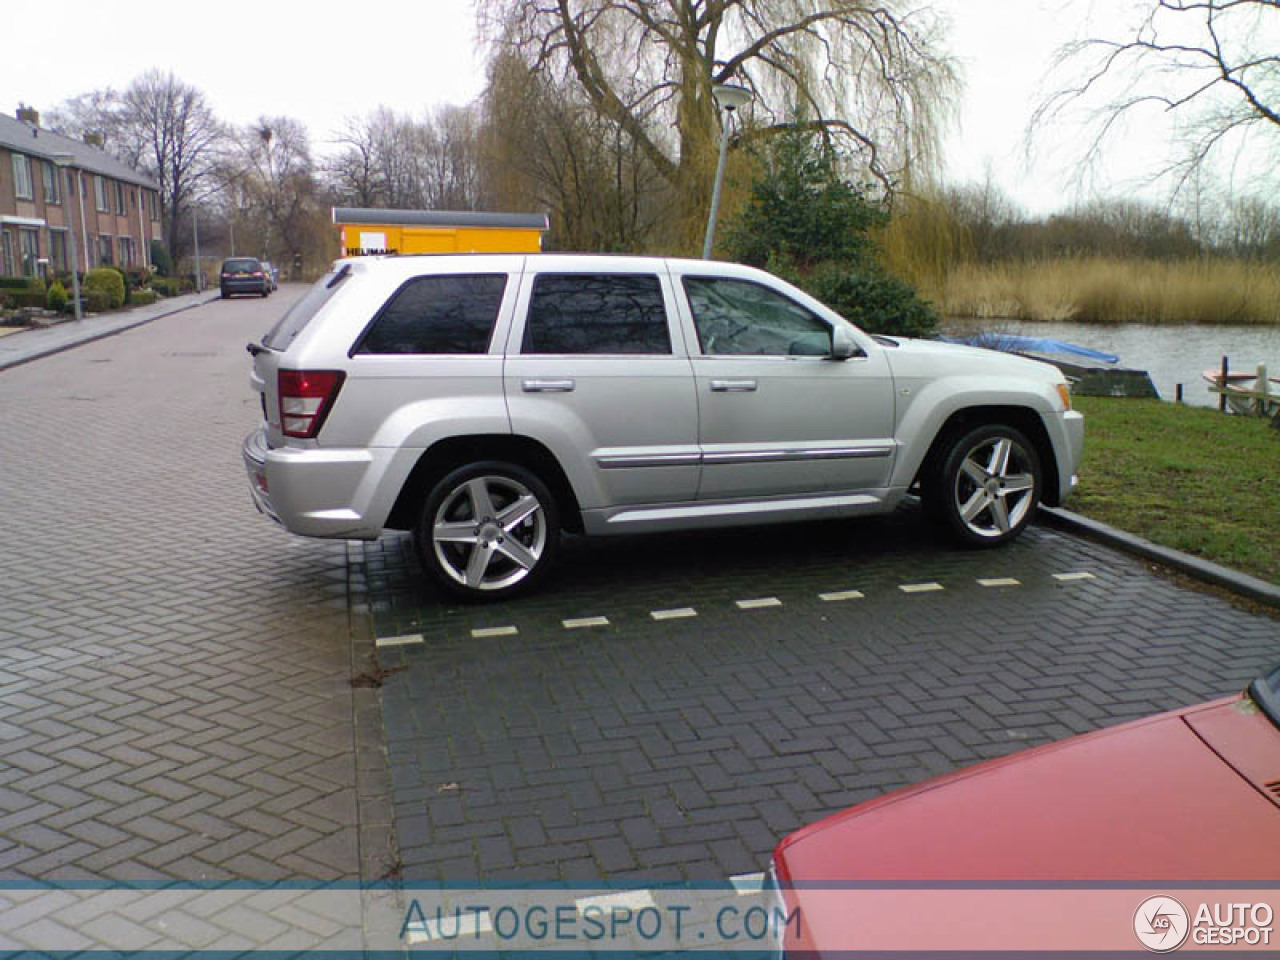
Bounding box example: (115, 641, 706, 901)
(243, 255, 1084, 599)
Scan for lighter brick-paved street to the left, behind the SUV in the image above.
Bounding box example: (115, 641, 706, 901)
(0, 288, 388, 881)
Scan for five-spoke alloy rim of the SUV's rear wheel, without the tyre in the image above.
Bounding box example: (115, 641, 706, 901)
(431, 475, 548, 590)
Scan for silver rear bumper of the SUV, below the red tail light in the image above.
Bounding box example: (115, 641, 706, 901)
(241, 428, 398, 540)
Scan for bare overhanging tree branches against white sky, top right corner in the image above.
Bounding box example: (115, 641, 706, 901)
(1032, 0, 1280, 197)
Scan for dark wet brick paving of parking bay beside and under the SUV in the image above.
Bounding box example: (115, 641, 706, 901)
(365, 509, 1280, 887)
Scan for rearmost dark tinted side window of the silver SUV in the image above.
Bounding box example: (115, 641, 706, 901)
(352, 274, 507, 356)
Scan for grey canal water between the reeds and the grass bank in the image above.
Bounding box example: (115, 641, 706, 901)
(942, 317, 1280, 407)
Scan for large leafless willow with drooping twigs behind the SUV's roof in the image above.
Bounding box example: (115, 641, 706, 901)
(481, 0, 954, 252)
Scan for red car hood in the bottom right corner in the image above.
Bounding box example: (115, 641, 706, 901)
(774, 698, 1280, 886)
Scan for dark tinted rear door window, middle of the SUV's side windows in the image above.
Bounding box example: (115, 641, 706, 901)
(522, 274, 671, 353)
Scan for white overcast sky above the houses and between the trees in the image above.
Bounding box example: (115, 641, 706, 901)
(0, 0, 1254, 212)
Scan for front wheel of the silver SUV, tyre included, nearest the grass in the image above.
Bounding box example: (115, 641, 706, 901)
(923, 424, 1043, 548)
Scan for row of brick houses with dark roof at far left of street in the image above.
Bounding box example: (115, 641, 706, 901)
(0, 106, 161, 284)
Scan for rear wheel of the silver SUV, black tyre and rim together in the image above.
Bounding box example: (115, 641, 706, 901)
(416, 461, 559, 600)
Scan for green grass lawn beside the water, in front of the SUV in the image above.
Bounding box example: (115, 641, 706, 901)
(1065, 397, 1280, 584)
